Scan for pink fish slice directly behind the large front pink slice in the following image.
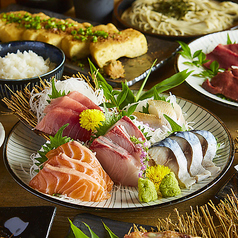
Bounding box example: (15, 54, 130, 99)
(105, 125, 141, 161)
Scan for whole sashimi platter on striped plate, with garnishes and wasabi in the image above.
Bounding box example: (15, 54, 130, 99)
(3, 63, 234, 210)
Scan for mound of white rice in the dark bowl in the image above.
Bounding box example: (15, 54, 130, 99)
(0, 50, 50, 79)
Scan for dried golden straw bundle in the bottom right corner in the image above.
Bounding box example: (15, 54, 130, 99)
(158, 191, 238, 238)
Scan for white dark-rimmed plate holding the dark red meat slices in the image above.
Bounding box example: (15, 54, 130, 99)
(177, 30, 238, 109)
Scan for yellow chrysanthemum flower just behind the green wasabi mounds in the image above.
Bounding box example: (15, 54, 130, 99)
(146, 164, 170, 192)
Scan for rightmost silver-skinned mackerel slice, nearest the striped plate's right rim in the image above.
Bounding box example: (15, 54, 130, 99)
(191, 130, 220, 174)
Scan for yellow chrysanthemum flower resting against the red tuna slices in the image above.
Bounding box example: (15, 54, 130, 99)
(79, 109, 105, 131)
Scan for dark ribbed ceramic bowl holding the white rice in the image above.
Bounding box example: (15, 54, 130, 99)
(0, 41, 65, 99)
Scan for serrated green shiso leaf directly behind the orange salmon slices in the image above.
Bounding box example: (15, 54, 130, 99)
(35, 124, 72, 164)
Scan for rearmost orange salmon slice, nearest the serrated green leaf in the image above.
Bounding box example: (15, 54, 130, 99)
(46, 141, 113, 191)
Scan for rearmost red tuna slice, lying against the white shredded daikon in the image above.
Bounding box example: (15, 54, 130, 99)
(44, 96, 88, 113)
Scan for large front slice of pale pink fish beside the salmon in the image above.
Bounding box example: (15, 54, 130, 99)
(90, 136, 141, 187)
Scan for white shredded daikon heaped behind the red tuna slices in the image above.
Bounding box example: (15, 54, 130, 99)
(29, 78, 104, 122)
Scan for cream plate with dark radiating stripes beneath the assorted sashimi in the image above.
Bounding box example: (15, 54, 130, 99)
(4, 98, 234, 210)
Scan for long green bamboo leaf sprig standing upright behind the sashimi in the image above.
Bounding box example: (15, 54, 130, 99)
(89, 59, 191, 137)
